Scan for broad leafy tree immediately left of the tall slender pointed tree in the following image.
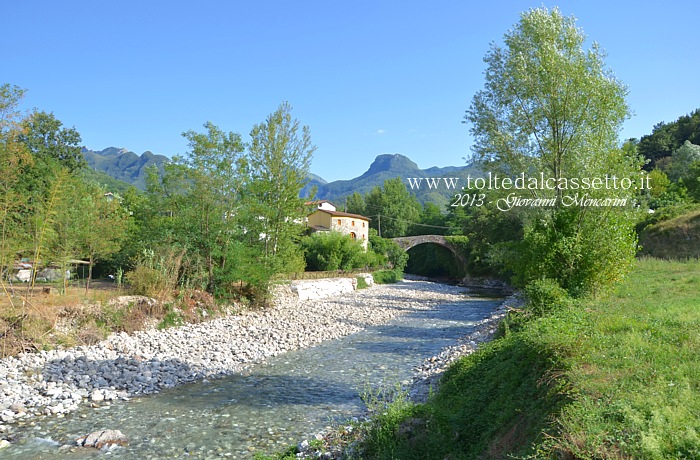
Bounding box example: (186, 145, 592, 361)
(144, 122, 246, 292)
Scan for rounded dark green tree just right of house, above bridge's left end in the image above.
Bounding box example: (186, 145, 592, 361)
(365, 177, 421, 238)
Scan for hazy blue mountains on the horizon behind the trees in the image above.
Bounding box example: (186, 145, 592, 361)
(83, 147, 478, 207)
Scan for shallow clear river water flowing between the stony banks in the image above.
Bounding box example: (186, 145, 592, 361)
(0, 288, 500, 459)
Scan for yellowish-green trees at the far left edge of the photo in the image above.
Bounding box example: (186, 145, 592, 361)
(0, 84, 127, 289)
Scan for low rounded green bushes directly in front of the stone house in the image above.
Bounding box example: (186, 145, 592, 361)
(301, 232, 367, 271)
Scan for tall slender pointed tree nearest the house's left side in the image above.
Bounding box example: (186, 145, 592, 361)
(246, 102, 316, 269)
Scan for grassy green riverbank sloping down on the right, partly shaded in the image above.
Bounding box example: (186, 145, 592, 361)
(362, 259, 700, 459)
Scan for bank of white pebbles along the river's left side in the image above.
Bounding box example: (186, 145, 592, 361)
(0, 281, 486, 438)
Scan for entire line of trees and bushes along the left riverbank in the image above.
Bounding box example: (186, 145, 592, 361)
(0, 85, 405, 306)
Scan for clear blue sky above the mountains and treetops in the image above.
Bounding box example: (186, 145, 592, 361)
(5, 0, 700, 181)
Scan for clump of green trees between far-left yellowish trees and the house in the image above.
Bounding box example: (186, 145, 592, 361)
(120, 103, 315, 297)
